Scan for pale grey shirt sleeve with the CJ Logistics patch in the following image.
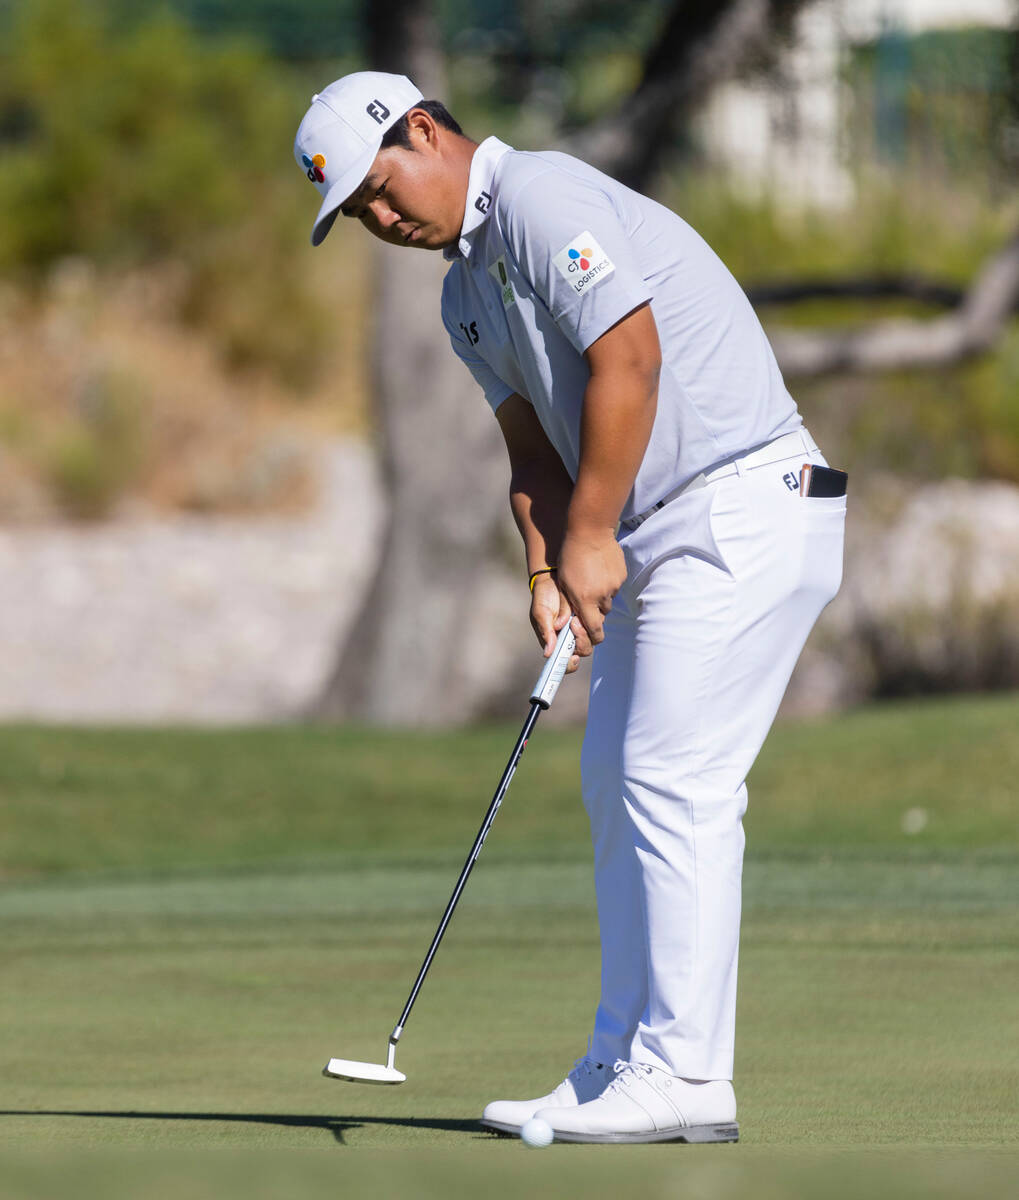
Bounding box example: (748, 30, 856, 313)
(502, 167, 652, 354)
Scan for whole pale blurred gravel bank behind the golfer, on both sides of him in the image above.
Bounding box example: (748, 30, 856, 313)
(7, 453, 1019, 724)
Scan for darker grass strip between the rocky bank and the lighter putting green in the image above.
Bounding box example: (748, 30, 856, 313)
(0, 695, 1019, 881)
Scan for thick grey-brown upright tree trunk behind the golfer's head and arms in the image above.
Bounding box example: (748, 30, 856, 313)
(316, 0, 509, 725)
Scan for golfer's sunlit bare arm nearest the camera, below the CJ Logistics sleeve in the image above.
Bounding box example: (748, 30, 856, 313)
(556, 304, 661, 644)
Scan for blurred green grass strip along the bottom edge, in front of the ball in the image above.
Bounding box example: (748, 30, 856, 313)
(0, 1141, 1019, 1200)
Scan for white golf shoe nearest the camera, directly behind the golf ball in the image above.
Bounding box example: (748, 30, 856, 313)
(534, 1060, 739, 1142)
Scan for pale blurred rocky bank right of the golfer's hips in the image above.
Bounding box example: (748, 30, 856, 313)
(784, 479, 1019, 714)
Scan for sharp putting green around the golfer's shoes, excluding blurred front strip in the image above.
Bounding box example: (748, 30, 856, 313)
(0, 863, 1019, 1147)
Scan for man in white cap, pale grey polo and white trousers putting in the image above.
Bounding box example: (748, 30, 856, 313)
(295, 72, 845, 1141)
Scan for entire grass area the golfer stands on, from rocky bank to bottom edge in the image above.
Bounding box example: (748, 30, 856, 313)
(0, 697, 1019, 1196)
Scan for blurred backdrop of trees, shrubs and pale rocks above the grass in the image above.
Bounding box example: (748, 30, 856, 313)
(0, 0, 1019, 725)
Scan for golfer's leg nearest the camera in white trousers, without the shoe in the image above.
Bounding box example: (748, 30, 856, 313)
(623, 475, 844, 1080)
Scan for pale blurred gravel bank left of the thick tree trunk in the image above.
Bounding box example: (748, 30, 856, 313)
(0, 442, 384, 722)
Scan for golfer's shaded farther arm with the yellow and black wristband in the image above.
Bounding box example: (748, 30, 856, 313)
(496, 394, 591, 671)
